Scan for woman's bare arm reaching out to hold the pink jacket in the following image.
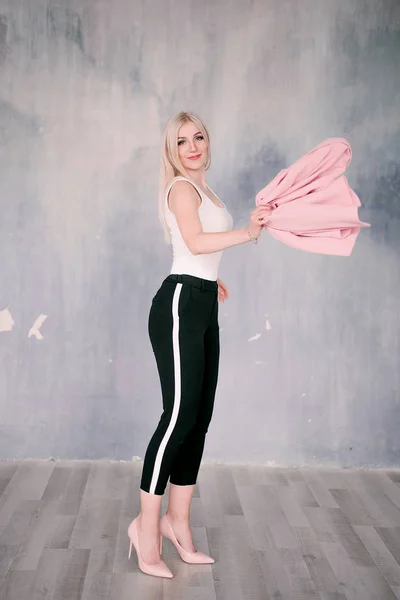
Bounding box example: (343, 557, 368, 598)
(169, 181, 270, 254)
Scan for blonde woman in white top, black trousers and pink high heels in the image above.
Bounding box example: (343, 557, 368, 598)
(128, 112, 271, 577)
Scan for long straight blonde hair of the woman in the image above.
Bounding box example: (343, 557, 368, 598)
(158, 112, 211, 244)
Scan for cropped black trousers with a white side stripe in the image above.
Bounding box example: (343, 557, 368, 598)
(140, 275, 219, 495)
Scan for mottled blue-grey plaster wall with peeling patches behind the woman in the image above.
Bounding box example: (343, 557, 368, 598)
(0, 0, 400, 466)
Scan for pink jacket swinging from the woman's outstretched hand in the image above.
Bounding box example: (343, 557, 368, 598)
(256, 138, 369, 256)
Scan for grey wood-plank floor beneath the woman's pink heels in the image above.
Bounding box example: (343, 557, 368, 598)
(0, 461, 400, 600)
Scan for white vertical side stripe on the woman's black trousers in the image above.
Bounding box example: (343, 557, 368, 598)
(149, 283, 182, 494)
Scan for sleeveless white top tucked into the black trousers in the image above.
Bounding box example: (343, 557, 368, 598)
(165, 177, 233, 281)
